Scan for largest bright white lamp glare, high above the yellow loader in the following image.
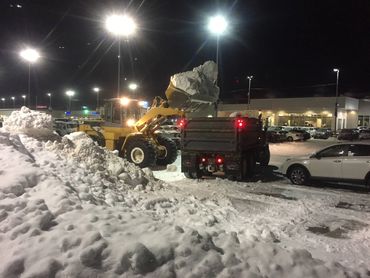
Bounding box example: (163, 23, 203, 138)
(105, 15, 136, 36)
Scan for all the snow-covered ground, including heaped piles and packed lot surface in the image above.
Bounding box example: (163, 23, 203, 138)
(0, 108, 370, 277)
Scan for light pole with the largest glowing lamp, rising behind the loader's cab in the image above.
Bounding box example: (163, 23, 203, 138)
(105, 14, 136, 98)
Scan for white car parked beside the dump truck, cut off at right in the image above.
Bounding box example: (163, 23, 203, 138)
(279, 143, 370, 187)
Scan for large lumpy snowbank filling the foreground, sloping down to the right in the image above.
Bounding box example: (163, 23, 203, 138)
(0, 109, 367, 277)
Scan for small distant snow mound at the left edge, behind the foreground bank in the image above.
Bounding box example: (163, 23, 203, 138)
(3, 106, 53, 131)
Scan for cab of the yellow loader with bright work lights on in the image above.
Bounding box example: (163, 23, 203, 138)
(104, 97, 147, 126)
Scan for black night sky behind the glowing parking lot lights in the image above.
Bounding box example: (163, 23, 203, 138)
(0, 0, 370, 107)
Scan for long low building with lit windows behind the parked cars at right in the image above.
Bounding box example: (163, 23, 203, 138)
(218, 96, 370, 129)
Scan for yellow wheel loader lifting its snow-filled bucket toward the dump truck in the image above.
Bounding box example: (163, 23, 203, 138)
(78, 61, 218, 168)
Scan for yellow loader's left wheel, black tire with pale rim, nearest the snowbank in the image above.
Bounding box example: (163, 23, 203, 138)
(125, 136, 156, 168)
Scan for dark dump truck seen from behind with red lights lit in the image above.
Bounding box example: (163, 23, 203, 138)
(181, 116, 270, 180)
